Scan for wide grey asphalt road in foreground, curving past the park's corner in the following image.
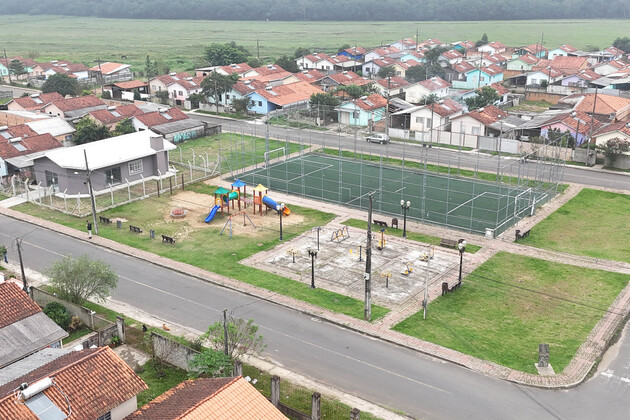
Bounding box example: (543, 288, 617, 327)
(0, 216, 630, 419)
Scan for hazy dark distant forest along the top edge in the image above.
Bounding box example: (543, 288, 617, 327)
(0, 0, 630, 21)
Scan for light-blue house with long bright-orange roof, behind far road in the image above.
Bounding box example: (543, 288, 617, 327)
(248, 82, 323, 114)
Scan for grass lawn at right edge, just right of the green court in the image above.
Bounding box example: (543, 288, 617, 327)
(520, 188, 630, 263)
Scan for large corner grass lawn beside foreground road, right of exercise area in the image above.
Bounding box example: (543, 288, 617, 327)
(394, 252, 630, 373)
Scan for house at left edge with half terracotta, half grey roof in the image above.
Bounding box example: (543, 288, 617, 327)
(0, 281, 68, 370)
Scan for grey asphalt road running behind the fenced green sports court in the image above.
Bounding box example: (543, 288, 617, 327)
(188, 113, 630, 190)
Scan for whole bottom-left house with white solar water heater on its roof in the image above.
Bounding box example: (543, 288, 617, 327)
(0, 347, 147, 420)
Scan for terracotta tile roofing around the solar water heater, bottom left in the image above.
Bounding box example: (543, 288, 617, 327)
(0, 347, 147, 420)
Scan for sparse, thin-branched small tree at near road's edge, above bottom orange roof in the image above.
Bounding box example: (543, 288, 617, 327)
(202, 315, 266, 360)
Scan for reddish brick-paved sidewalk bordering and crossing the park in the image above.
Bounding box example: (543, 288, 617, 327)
(0, 187, 630, 388)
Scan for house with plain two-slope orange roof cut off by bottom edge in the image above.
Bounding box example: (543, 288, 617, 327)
(127, 376, 287, 420)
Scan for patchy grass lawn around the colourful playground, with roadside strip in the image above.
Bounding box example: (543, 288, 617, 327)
(14, 184, 388, 320)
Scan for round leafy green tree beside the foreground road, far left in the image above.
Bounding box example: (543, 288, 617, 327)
(46, 254, 118, 304)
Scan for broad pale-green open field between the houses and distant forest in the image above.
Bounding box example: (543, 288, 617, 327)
(0, 15, 630, 71)
